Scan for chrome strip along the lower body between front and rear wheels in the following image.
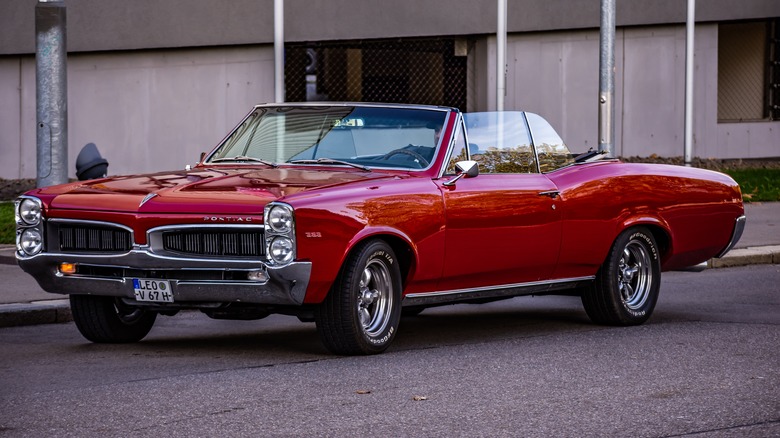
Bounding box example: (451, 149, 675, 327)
(403, 275, 596, 306)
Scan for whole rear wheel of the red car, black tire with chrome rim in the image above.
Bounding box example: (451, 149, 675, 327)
(582, 227, 661, 326)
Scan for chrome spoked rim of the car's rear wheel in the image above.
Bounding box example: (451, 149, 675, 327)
(617, 240, 653, 310)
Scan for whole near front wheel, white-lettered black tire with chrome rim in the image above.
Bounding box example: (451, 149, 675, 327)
(314, 239, 401, 355)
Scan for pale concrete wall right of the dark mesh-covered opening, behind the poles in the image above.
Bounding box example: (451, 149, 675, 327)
(472, 24, 780, 158)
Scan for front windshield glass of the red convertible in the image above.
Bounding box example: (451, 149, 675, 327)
(206, 106, 447, 169)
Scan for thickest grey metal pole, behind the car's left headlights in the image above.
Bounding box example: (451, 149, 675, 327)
(35, 0, 68, 187)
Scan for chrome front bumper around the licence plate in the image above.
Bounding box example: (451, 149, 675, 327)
(17, 249, 311, 305)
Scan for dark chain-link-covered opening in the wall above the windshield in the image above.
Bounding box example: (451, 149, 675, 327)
(285, 38, 470, 111)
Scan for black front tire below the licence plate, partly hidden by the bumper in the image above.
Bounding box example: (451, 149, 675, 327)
(70, 295, 157, 344)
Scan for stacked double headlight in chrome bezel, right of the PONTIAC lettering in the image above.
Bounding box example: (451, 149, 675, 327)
(263, 202, 297, 266)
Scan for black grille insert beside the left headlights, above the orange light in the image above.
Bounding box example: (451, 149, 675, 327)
(57, 224, 132, 252)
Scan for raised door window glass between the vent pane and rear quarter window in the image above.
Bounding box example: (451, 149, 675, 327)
(466, 111, 539, 173)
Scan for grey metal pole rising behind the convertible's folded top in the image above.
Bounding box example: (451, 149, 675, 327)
(599, 0, 615, 156)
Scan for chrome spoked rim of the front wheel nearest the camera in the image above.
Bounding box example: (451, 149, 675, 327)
(357, 260, 393, 336)
